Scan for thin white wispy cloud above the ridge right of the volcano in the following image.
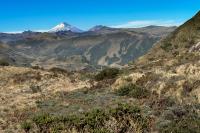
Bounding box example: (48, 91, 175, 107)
(111, 20, 182, 28)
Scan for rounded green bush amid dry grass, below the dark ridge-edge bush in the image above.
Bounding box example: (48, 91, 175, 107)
(116, 83, 149, 98)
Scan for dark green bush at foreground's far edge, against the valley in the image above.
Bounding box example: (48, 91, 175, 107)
(95, 68, 120, 81)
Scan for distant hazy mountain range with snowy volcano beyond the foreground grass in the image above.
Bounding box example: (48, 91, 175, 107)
(0, 23, 176, 70)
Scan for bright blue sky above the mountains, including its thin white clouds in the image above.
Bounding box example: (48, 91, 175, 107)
(0, 0, 200, 32)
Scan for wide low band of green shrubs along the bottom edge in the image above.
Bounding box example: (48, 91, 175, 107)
(23, 104, 149, 133)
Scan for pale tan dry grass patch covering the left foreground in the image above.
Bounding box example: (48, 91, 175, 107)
(0, 67, 89, 132)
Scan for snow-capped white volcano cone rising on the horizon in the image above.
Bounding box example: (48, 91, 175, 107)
(49, 22, 82, 32)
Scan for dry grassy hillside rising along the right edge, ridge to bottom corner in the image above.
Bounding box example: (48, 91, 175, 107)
(113, 12, 200, 133)
